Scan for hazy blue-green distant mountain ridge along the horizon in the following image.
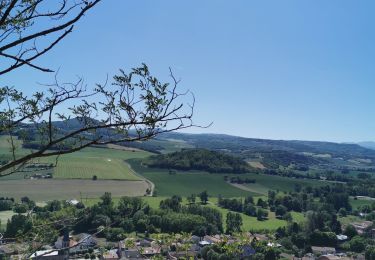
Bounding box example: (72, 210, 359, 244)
(5, 118, 375, 167)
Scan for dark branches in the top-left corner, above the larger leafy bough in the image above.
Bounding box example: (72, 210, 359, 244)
(0, 0, 101, 75)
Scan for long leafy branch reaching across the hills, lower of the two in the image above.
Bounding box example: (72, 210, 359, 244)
(0, 64, 200, 176)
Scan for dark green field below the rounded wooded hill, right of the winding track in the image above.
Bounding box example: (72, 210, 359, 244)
(129, 160, 324, 197)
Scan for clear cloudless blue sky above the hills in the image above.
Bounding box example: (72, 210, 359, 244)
(2, 0, 375, 142)
